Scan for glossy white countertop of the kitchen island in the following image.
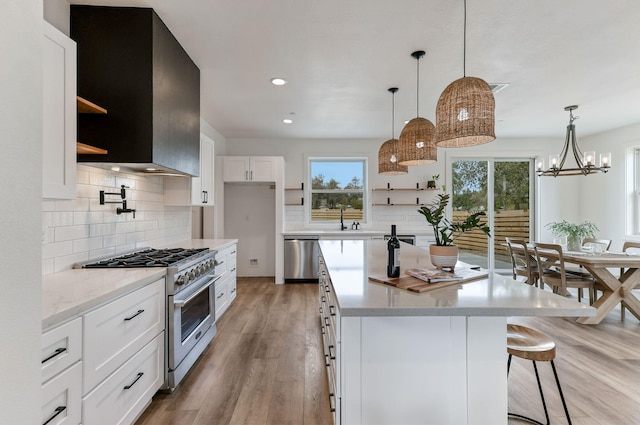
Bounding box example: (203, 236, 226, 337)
(320, 239, 596, 317)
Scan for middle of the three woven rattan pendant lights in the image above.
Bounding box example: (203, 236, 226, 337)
(398, 50, 438, 165)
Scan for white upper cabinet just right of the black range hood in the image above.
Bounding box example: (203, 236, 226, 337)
(164, 133, 215, 207)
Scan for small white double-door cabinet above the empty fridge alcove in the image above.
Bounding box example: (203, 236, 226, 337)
(222, 156, 278, 182)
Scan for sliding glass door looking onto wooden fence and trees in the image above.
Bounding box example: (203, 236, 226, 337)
(451, 158, 534, 272)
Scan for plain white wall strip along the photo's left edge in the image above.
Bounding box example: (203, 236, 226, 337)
(0, 0, 43, 424)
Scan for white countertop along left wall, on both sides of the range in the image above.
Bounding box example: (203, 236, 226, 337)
(42, 239, 237, 329)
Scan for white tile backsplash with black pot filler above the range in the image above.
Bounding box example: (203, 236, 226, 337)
(42, 165, 192, 274)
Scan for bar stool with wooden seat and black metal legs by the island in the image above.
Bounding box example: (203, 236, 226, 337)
(507, 324, 571, 425)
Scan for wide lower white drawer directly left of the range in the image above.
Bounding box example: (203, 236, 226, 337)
(82, 332, 164, 425)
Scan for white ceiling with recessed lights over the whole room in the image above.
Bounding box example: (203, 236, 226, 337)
(71, 0, 640, 141)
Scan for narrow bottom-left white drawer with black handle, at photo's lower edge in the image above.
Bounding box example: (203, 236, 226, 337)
(40, 362, 82, 425)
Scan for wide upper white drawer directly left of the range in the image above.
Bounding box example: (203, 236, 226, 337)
(82, 279, 167, 394)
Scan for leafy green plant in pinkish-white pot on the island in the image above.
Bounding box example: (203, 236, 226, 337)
(418, 193, 491, 269)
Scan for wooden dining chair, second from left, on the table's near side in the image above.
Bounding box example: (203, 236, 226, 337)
(533, 242, 594, 304)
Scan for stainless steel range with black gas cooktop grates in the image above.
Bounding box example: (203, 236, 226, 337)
(76, 248, 219, 391)
